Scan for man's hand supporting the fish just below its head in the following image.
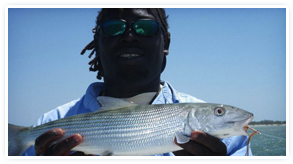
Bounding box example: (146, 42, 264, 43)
(173, 131, 227, 156)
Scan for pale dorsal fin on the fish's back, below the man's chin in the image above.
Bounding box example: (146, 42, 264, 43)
(97, 96, 136, 110)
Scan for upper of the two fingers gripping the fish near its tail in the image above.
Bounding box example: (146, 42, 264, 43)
(35, 129, 64, 155)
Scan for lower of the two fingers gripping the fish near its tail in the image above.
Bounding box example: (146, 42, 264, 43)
(44, 134, 82, 156)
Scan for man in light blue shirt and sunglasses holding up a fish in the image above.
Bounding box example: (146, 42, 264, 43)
(24, 9, 251, 156)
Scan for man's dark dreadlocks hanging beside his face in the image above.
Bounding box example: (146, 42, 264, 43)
(81, 8, 169, 80)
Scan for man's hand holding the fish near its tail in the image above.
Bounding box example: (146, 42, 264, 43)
(35, 129, 89, 156)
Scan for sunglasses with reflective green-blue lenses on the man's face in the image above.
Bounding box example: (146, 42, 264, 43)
(97, 19, 164, 36)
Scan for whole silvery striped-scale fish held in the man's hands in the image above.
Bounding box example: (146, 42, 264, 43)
(8, 96, 254, 156)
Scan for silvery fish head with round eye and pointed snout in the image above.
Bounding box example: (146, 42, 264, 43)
(187, 103, 253, 138)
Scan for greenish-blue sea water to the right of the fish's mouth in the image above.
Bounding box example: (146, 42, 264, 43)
(248, 125, 286, 156)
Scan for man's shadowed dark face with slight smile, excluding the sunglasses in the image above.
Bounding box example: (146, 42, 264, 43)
(97, 9, 166, 85)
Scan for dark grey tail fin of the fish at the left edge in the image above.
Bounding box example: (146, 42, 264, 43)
(8, 124, 30, 156)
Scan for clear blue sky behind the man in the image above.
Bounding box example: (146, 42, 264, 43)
(8, 8, 286, 126)
